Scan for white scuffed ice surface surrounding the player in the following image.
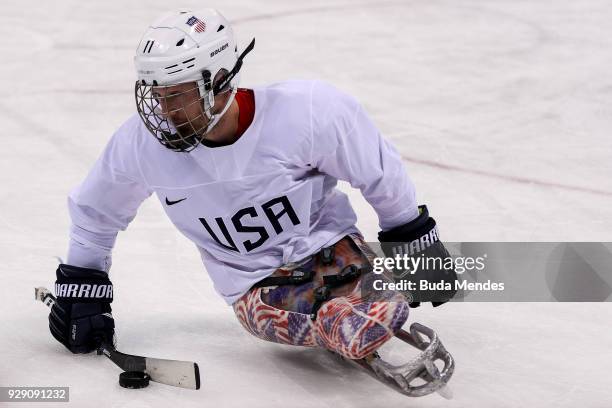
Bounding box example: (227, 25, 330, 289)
(0, 0, 612, 408)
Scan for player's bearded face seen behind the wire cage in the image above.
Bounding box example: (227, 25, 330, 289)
(153, 82, 208, 137)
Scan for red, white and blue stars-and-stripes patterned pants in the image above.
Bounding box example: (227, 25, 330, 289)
(233, 234, 408, 359)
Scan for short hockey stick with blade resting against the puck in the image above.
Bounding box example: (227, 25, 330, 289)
(34, 287, 200, 390)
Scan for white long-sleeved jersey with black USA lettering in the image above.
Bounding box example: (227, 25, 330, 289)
(67, 81, 418, 304)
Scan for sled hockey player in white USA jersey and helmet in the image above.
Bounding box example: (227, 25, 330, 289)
(49, 10, 454, 395)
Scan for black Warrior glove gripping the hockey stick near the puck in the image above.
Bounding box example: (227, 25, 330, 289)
(49, 264, 115, 353)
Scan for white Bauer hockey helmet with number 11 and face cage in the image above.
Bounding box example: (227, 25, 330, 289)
(134, 9, 255, 152)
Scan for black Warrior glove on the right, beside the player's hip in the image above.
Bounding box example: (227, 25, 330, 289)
(378, 205, 457, 307)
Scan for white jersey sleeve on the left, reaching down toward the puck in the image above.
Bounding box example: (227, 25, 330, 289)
(66, 117, 152, 271)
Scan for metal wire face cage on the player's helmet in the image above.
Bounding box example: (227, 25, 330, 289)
(134, 69, 233, 152)
